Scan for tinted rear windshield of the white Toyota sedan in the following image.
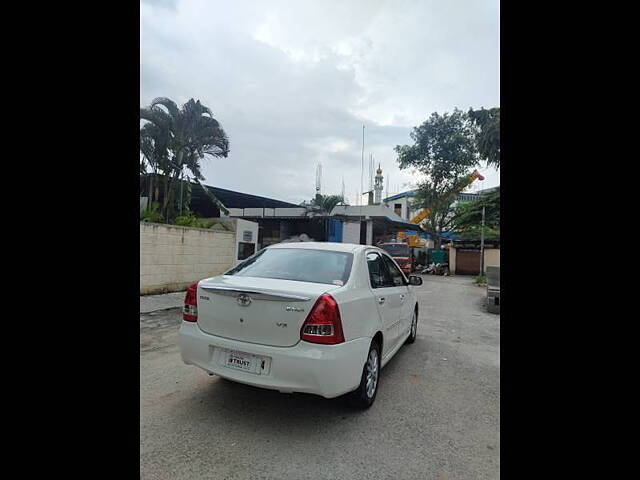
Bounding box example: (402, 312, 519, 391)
(226, 248, 353, 285)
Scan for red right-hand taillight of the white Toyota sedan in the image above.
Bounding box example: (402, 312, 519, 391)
(300, 293, 344, 345)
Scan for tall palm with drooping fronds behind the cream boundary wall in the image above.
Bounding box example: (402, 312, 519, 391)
(140, 97, 229, 220)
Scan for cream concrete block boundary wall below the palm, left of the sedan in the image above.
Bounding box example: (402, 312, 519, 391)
(140, 222, 236, 294)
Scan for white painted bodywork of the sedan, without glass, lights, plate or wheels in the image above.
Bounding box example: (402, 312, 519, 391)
(179, 242, 417, 398)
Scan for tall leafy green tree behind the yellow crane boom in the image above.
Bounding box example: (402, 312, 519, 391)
(395, 109, 478, 249)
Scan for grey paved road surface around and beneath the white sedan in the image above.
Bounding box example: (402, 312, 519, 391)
(140, 276, 500, 480)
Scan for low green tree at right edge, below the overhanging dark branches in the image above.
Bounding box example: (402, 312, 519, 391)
(452, 187, 500, 240)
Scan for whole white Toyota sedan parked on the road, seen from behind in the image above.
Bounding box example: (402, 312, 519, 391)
(180, 242, 422, 408)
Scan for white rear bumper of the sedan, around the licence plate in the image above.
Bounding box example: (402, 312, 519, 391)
(179, 322, 371, 398)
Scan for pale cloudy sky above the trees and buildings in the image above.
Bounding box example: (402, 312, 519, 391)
(140, 0, 500, 205)
